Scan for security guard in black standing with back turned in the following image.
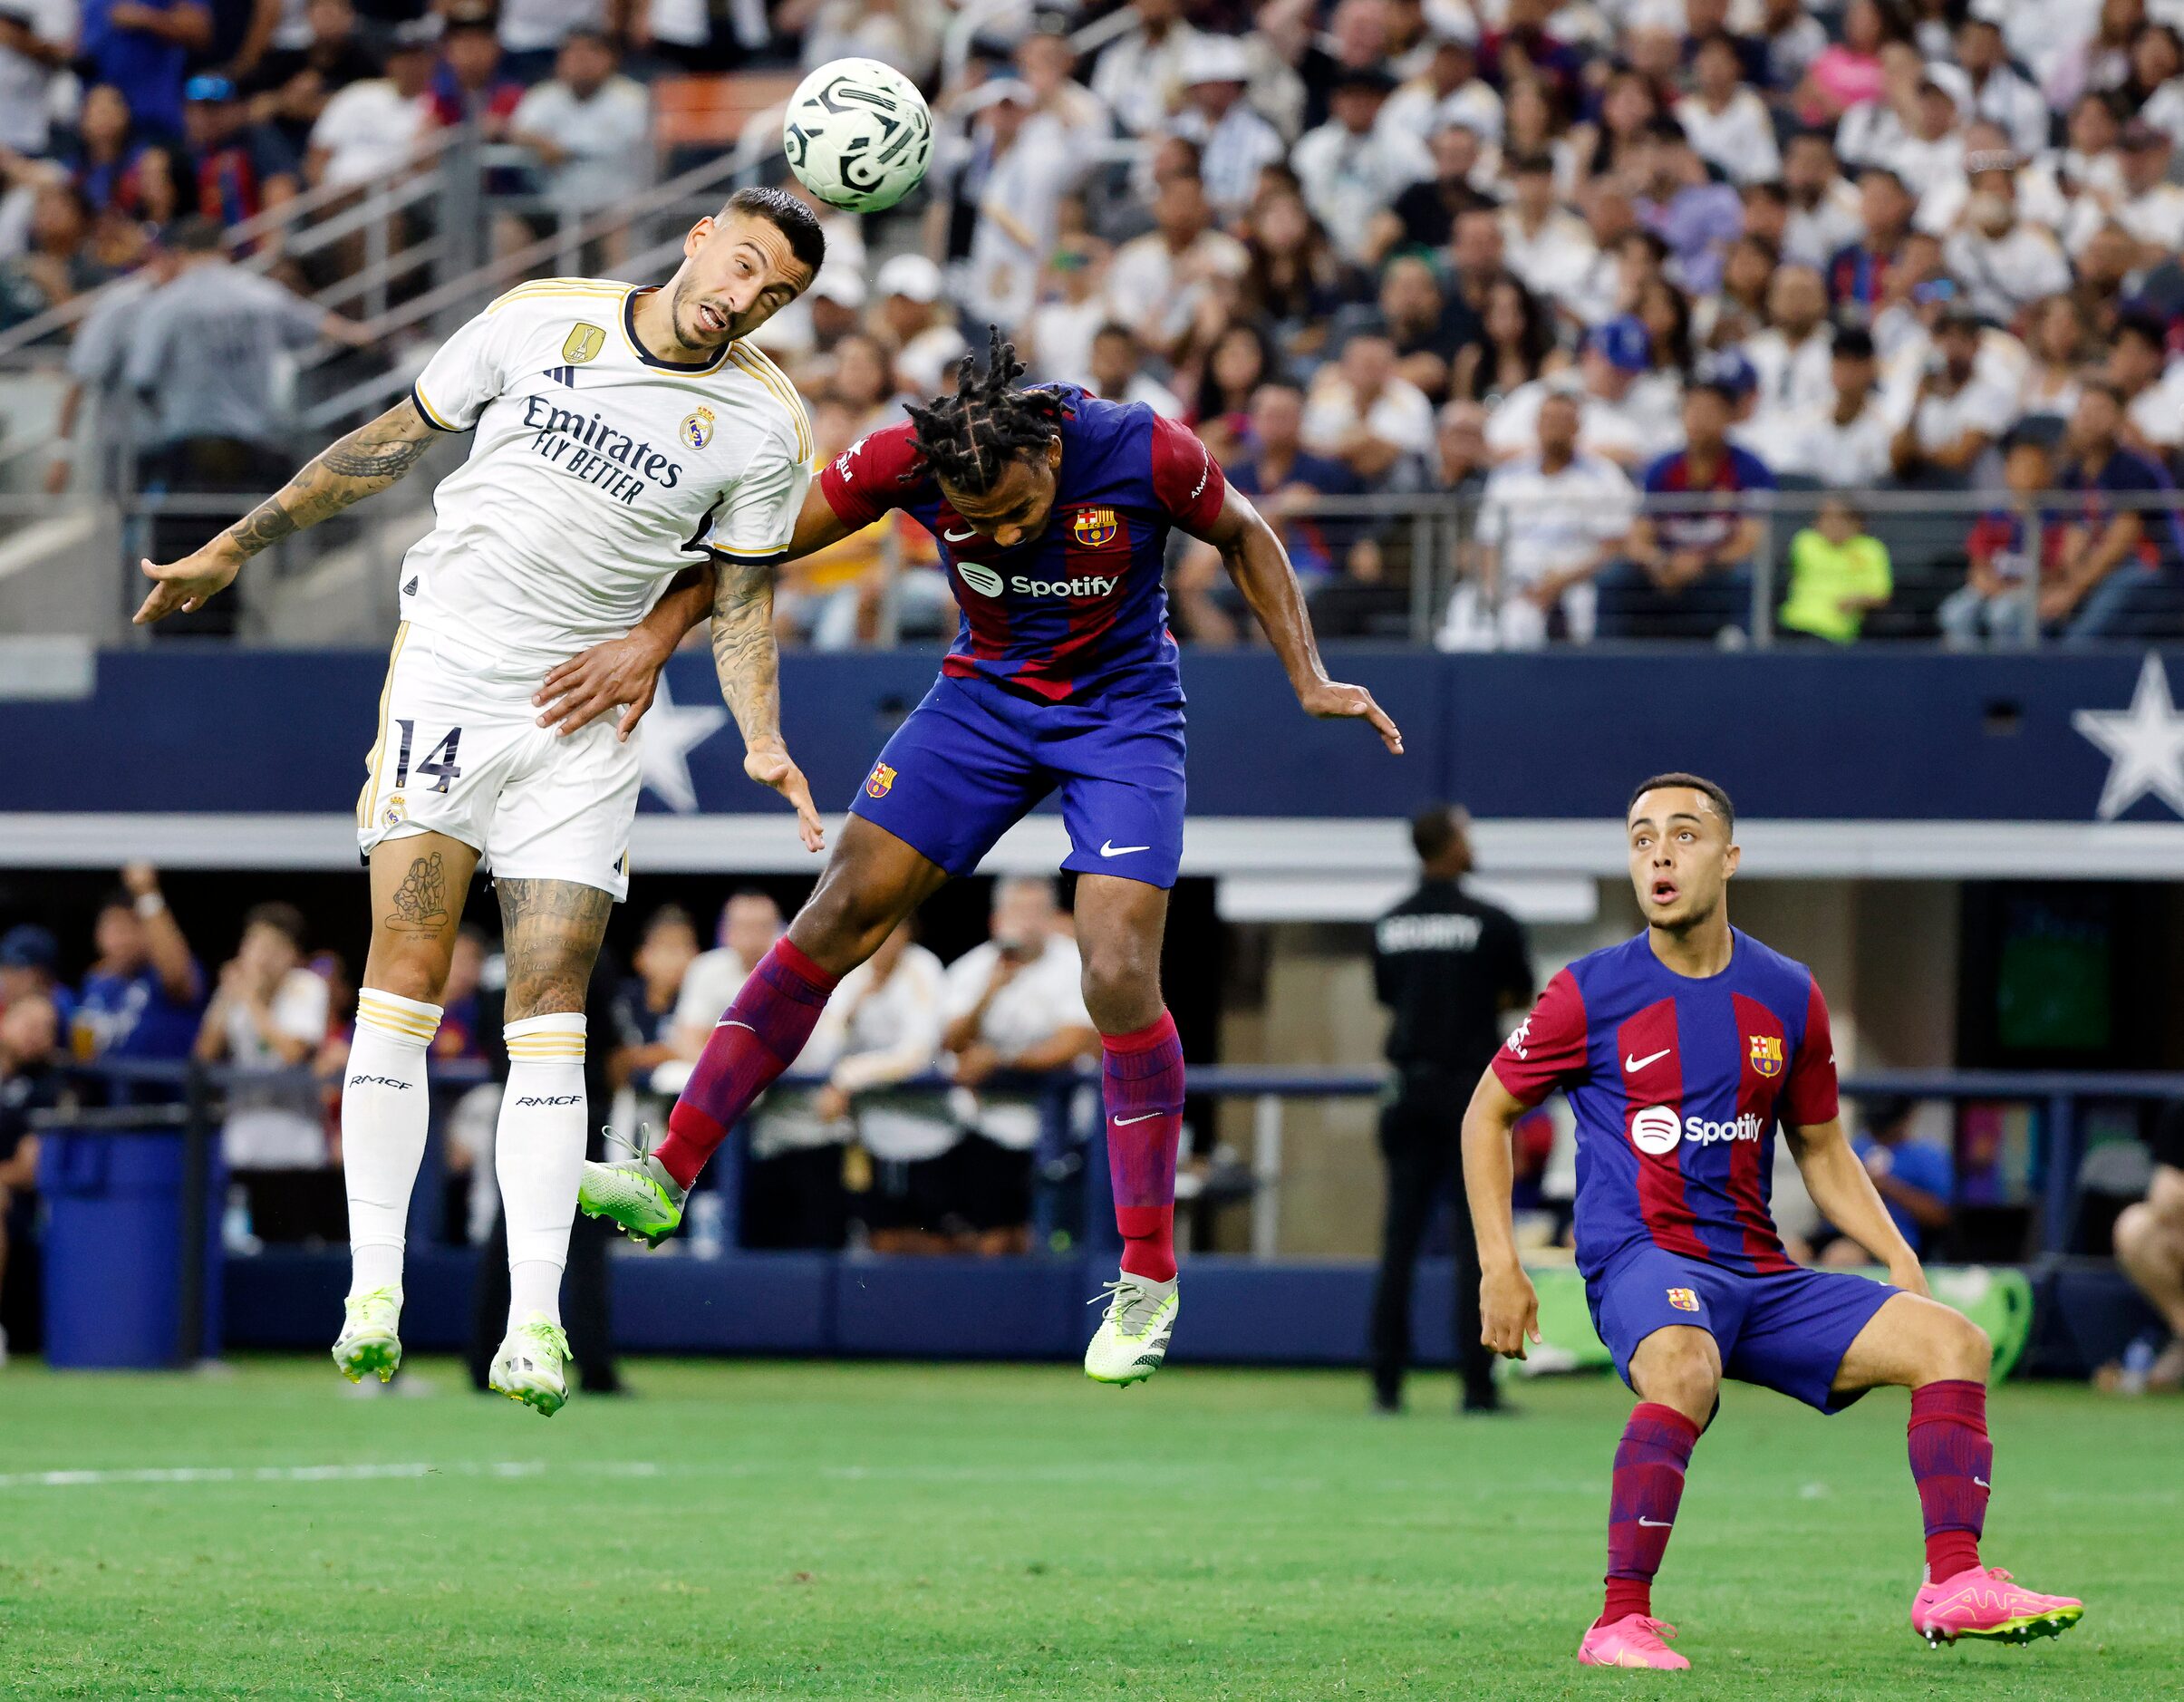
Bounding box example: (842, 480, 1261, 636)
(1371, 804, 1533, 1411)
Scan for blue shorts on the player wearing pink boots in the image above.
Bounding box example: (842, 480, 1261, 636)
(1586, 1245, 1902, 1411)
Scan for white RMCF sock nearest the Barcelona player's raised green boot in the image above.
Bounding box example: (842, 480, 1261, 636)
(494, 1011, 590, 1330)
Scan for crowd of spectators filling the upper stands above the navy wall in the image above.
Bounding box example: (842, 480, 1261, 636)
(0, 0, 2184, 647)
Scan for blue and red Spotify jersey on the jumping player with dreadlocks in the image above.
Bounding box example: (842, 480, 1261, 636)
(819, 384, 1227, 703)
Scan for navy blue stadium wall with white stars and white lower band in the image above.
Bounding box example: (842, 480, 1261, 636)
(13, 644, 2184, 878)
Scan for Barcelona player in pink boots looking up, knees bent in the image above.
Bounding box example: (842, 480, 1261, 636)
(1464, 773, 2083, 1667)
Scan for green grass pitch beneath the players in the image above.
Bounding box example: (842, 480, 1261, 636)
(0, 1361, 2184, 1702)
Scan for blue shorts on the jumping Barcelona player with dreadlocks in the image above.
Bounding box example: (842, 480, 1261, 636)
(849, 675, 1184, 887)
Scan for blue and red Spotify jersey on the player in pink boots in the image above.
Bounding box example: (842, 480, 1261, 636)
(1492, 929, 1837, 1278)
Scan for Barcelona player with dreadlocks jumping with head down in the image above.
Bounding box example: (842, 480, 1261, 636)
(542, 332, 1402, 1383)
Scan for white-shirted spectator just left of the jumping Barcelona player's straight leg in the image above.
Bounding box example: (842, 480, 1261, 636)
(942, 876, 1098, 1254)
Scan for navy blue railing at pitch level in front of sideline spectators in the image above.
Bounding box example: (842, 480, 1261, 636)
(33, 1059, 2184, 1357)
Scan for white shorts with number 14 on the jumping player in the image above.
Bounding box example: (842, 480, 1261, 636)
(356, 623, 644, 900)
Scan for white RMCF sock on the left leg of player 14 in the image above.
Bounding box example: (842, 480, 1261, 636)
(341, 988, 439, 1296)
